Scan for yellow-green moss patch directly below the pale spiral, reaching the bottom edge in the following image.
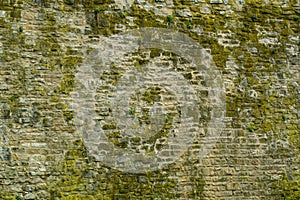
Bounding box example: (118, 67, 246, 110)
(48, 140, 183, 199)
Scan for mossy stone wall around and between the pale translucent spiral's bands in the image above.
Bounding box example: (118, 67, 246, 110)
(0, 0, 300, 200)
